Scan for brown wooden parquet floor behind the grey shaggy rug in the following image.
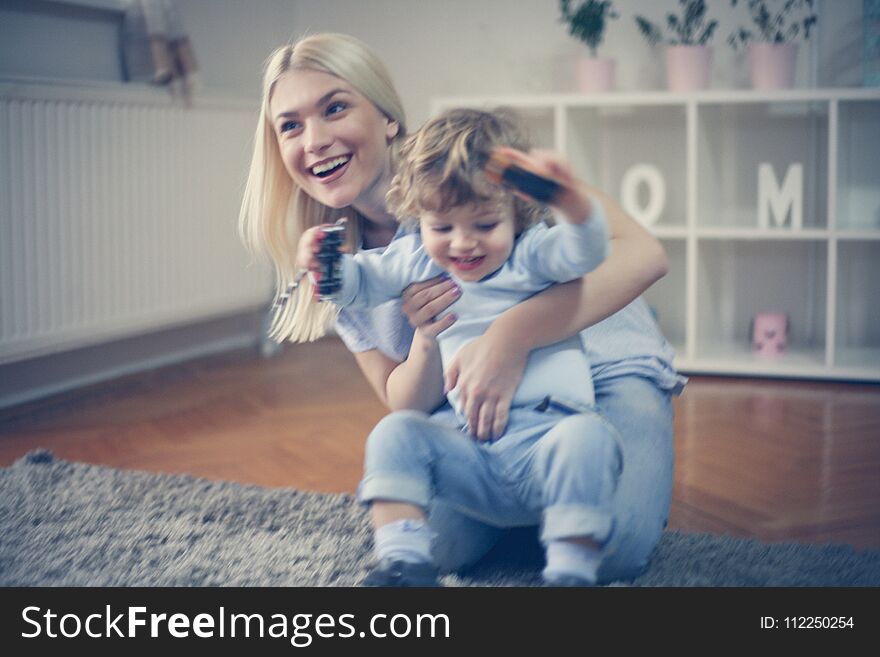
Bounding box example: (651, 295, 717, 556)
(0, 338, 880, 549)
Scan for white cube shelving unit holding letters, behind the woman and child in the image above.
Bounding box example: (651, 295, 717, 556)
(432, 89, 880, 381)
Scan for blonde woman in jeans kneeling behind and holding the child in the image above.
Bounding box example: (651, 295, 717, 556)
(240, 34, 683, 581)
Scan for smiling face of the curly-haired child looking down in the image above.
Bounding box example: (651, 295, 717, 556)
(419, 198, 516, 281)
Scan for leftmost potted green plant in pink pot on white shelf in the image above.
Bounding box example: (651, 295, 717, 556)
(559, 0, 620, 93)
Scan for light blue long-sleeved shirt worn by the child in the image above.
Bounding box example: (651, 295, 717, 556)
(336, 202, 608, 416)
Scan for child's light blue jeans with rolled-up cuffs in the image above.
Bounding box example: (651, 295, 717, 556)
(358, 404, 621, 543)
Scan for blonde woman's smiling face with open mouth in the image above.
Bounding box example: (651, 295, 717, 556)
(269, 69, 399, 208)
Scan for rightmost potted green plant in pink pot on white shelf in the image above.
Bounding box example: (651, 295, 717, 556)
(727, 0, 818, 89)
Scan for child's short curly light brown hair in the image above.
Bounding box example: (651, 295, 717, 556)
(386, 108, 545, 234)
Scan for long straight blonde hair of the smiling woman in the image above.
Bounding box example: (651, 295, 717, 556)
(238, 33, 406, 342)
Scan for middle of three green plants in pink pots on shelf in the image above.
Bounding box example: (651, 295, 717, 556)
(635, 0, 718, 91)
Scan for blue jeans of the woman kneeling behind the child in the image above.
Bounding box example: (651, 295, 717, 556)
(384, 375, 674, 582)
